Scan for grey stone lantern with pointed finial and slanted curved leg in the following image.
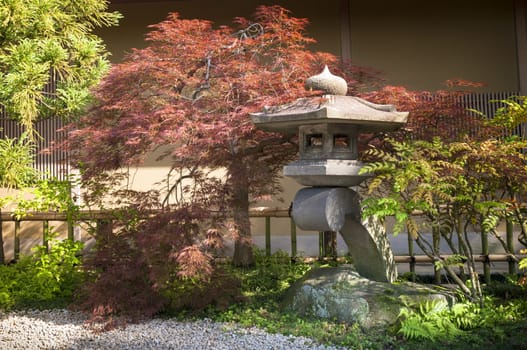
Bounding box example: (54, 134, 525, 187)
(251, 67, 408, 282)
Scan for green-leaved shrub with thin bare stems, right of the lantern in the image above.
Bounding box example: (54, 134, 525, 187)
(361, 133, 527, 301)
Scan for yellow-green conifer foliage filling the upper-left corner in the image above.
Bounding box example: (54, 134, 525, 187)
(0, 0, 120, 134)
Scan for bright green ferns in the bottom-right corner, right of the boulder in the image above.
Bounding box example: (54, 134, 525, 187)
(395, 296, 527, 349)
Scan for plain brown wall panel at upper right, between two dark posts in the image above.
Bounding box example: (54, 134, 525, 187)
(351, 0, 518, 91)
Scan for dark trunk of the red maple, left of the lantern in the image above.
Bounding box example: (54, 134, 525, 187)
(231, 164, 254, 267)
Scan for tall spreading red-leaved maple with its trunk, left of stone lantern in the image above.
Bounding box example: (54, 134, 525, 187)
(68, 6, 380, 265)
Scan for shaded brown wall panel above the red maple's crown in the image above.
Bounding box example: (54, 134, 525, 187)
(99, 0, 340, 62)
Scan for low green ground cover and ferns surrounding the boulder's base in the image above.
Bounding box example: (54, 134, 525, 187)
(204, 251, 527, 349)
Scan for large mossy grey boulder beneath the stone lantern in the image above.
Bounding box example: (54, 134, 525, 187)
(283, 265, 454, 328)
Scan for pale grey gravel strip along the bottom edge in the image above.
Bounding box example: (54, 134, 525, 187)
(0, 310, 344, 350)
